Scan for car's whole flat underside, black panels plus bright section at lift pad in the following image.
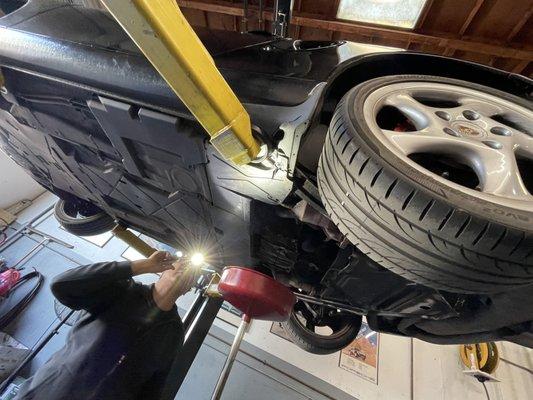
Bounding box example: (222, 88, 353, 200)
(0, 68, 320, 265)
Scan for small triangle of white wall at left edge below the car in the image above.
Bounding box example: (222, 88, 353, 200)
(0, 151, 45, 208)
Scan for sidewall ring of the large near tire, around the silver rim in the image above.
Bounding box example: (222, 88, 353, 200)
(346, 75, 533, 231)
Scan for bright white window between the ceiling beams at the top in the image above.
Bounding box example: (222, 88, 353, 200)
(337, 0, 426, 29)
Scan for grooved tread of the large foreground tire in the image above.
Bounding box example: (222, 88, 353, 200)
(318, 76, 533, 293)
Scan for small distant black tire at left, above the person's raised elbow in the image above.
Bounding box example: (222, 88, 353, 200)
(54, 200, 116, 236)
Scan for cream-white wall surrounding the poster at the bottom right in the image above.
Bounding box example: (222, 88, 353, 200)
(245, 321, 533, 400)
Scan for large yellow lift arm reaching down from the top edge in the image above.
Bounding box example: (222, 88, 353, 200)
(102, 0, 260, 164)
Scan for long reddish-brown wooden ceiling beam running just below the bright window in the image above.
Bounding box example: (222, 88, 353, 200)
(177, 0, 533, 61)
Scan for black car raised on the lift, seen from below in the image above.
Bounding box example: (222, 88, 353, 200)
(0, 0, 533, 354)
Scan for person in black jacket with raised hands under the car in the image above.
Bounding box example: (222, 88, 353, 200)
(16, 251, 197, 400)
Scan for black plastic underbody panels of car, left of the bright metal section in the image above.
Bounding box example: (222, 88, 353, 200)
(0, 70, 231, 260)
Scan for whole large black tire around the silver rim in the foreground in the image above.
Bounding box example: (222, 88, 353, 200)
(318, 75, 533, 293)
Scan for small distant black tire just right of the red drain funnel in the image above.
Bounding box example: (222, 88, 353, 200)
(282, 312, 362, 354)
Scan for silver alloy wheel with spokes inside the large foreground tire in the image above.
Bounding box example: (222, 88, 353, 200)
(374, 82, 533, 204)
